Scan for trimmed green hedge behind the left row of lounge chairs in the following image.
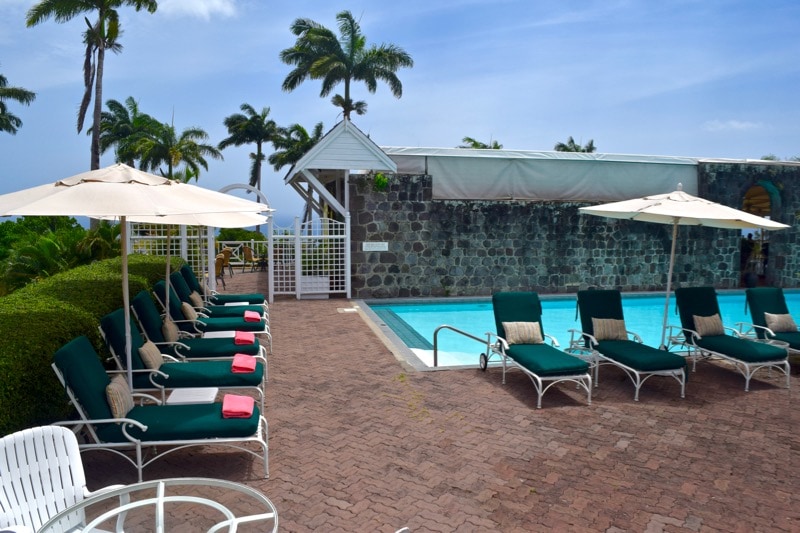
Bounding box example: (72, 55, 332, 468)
(0, 255, 182, 435)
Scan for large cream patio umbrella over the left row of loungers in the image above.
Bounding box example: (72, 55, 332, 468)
(0, 163, 266, 384)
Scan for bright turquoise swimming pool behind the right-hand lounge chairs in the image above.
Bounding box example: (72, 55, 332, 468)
(365, 290, 800, 369)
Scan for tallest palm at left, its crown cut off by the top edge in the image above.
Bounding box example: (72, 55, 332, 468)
(26, 0, 158, 170)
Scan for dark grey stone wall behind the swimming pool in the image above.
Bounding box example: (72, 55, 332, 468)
(349, 165, 800, 298)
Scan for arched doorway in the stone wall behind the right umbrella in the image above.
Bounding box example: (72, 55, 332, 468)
(740, 180, 780, 287)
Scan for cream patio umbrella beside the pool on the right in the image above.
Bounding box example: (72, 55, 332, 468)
(578, 183, 789, 348)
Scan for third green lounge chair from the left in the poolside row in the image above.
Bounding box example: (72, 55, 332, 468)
(670, 287, 790, 391)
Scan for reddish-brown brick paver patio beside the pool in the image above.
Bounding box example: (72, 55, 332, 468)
(83, 272, 800, 532)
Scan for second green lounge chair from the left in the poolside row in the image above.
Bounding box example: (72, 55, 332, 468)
(570, 290, 687, 401)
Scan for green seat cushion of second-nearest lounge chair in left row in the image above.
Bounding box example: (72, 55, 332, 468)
(133, 361, 264, 389)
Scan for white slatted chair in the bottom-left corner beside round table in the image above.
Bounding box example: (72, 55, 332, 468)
(0, 426, 124, 532)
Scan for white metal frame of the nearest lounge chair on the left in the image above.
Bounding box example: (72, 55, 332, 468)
(51, 363, 269, 482)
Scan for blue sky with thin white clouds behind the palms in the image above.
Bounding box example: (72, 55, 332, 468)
(0, 0, 800, 224)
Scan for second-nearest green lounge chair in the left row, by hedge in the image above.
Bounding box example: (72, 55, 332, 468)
(100, 309, 266, 410)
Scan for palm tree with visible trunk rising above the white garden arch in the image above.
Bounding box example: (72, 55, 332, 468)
(217, 104, 278, 191)
